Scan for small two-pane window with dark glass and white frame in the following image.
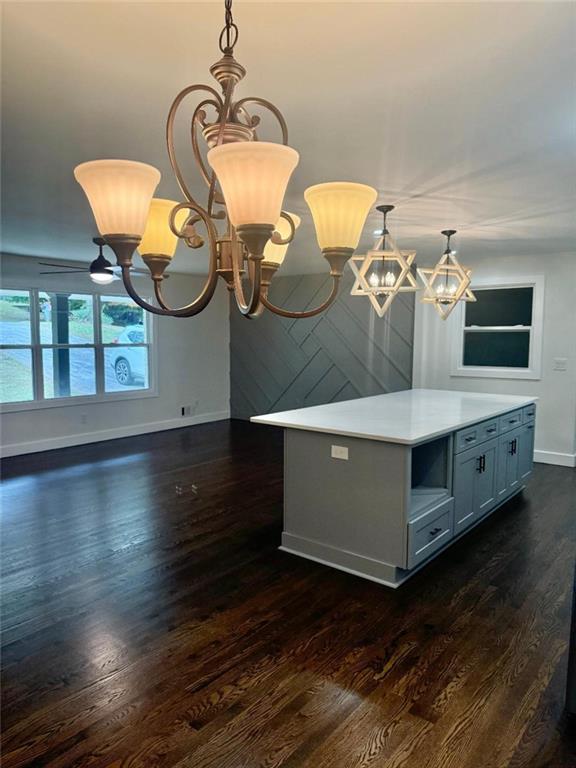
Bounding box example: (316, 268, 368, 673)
(452, 277, 543, 379)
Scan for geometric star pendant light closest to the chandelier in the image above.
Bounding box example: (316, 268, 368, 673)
(350, 205, 418, 317)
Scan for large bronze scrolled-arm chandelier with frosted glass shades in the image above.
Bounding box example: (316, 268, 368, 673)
(74, 0, 377, 318)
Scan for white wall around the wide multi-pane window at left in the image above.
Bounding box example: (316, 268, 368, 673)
(1, 256, 230, 455)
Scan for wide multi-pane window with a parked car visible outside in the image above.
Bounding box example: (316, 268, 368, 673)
(0, 290, 150, 409)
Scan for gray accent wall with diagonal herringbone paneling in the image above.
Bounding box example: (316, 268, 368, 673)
(230, 270, 414, 419)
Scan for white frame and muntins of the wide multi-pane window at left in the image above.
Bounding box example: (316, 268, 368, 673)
(0, 282, 158, 413)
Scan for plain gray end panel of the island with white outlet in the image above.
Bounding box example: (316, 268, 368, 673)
(283, 429, 411, 568)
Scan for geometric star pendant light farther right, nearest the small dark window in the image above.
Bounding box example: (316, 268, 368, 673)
(418, 229, 476, 320)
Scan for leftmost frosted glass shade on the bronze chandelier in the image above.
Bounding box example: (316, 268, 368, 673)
(74, 160, 160, 237)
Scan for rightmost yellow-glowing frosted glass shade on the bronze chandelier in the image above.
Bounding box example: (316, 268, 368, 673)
(304, 181, 377, 250)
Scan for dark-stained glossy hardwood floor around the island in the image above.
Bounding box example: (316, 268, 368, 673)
(2, 422, 576, 768)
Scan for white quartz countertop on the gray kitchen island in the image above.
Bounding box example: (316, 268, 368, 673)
(251, 389, 538, 445)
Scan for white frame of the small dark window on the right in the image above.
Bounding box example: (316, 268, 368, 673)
(450, 275, 545, 381)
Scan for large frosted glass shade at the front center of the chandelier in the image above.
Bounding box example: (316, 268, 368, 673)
(207, 141, 300, 227)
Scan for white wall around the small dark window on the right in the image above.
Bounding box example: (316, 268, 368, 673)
(414, 253, 576, 466)
